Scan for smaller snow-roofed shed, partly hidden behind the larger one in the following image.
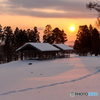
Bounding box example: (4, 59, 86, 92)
(53, 44, 74, 57)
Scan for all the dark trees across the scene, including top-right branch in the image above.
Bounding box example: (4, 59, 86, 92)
(0, 2, 100, 63)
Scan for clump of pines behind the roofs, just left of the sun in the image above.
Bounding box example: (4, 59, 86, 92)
(43, 25, 67, 44)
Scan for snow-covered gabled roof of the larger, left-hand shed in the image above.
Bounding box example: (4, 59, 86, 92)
(16, 42, 59, 51)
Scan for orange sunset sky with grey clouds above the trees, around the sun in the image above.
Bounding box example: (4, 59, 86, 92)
(0, 0, 97, 41)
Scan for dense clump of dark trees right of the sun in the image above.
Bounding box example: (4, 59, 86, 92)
(74, 25, 100, 56)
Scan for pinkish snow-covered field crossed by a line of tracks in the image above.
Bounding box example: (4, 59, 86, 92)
(0, 55, 100, 100)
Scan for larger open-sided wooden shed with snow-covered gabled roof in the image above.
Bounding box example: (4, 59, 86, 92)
(16, 42, 60, 60)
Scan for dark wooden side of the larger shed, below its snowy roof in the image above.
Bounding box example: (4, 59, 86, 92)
(18, 50, 57, 60)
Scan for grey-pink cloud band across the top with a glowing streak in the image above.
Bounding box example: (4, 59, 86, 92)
(0, 0, 95, 18)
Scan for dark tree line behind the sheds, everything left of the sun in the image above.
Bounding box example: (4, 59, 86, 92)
(0, 25, 67, 63)
